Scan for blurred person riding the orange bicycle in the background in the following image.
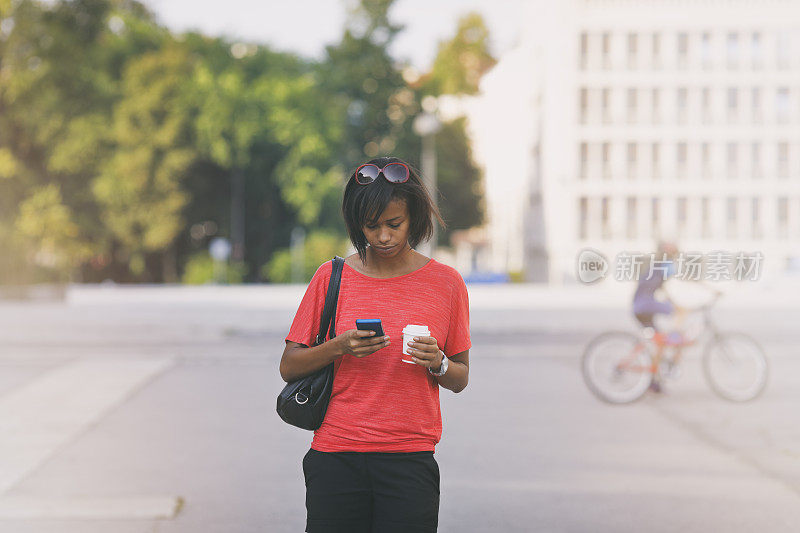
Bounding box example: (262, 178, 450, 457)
(633, 241, 687, 392)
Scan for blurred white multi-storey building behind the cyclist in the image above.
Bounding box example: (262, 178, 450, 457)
(468, 0, 800, 283)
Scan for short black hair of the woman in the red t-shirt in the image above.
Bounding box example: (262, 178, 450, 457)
(342, 157, 447, 263)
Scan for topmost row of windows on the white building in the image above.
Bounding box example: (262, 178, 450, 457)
(578, 29, 800, 70)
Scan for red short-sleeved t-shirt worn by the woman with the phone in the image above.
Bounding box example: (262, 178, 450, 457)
(286, 259, 471, 452)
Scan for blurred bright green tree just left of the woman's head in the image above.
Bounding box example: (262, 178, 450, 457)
(193, 43, 342, 280)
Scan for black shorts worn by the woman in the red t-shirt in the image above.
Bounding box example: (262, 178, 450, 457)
(303, 450, 439, 533)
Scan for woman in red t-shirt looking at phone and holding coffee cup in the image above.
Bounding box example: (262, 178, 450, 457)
(280, 157, 471, 533)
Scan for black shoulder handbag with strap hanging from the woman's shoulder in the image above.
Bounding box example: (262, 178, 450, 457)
(277, 255, 344, 431)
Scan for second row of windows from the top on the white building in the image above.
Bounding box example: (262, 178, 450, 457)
(578, 87, 800, 124)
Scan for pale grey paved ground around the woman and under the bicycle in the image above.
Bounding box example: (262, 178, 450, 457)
(0, 296, 800, 533)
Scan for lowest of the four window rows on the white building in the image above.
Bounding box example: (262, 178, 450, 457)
(578, 196, 789, 240)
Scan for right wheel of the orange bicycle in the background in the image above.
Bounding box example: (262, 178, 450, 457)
(703, 333, 769, 402)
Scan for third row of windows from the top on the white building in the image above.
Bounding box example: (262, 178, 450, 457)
(578, 141, 800, 179)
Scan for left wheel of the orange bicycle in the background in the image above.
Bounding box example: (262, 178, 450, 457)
(581, 331, 653, 403)
